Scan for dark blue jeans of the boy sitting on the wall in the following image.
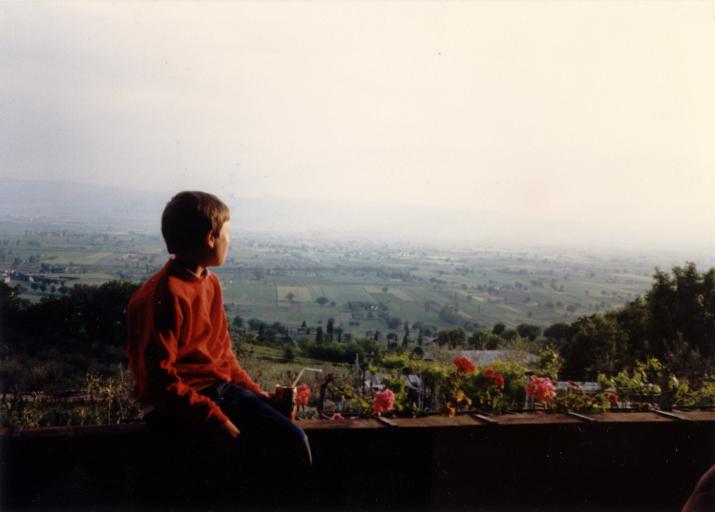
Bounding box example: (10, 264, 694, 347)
(145, 383, 312, 508)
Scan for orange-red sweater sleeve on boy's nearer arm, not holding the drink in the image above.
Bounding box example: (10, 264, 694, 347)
(146, 298, 228, 426)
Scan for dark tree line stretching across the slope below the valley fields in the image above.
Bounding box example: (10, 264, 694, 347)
(0, 263, 715, 391)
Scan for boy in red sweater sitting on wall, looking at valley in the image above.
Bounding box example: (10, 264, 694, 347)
(127, 192, 311, 496)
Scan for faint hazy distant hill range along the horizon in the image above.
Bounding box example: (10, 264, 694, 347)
(0, 177, 712, 261)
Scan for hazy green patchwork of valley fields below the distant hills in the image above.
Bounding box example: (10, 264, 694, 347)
(7, 221, 713, 336)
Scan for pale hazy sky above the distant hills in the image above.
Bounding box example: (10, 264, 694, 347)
(0, 2, 715, 249)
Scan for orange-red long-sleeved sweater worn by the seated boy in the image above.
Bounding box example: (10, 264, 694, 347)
(127, 260, 262, 425)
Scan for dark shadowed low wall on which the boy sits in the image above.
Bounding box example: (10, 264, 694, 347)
(0, 412, 715, 510)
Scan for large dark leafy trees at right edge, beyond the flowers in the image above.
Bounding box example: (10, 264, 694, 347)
(544, 263, 715, 379)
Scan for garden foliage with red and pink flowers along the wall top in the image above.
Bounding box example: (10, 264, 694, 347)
(2, 354, 715, 428)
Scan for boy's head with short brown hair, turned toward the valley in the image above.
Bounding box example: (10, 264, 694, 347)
(161, 191, 230, 254)
